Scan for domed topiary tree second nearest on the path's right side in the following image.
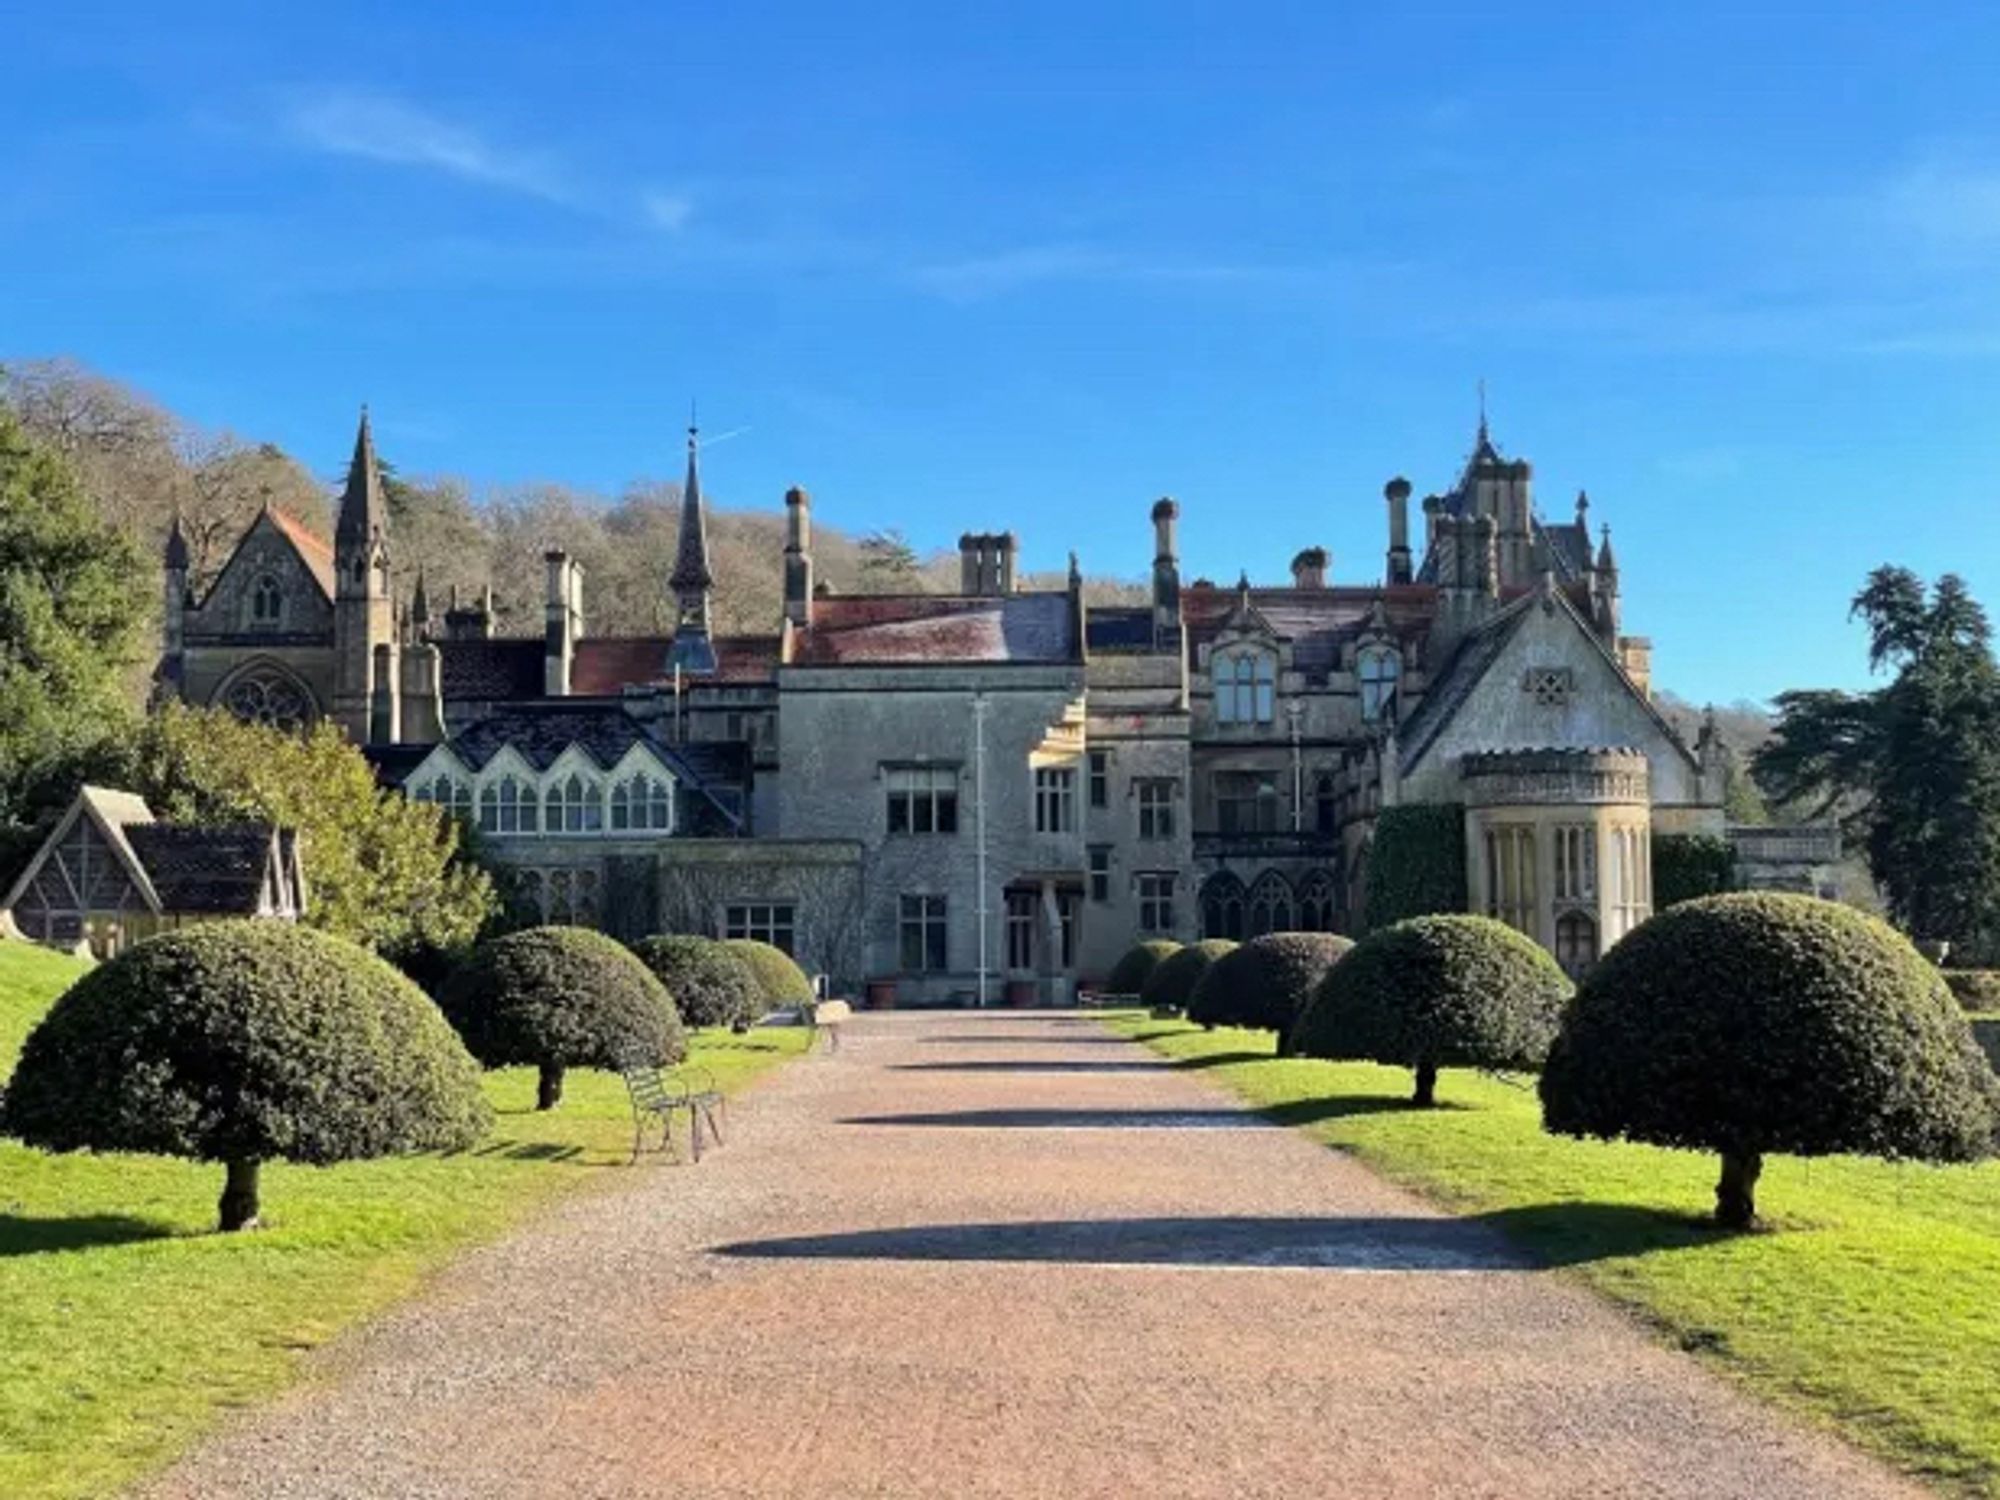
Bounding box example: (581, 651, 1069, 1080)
(1292, 914, 1570, 1106)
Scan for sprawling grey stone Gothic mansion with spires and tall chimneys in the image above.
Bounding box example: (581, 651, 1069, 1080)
(160, 416, 1722, 1002)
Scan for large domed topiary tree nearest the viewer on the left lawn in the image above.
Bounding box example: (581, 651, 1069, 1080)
(0, 922, 492, 1230)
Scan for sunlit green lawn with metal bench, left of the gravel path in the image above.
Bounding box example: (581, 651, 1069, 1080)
(0, 942, 810, 1500)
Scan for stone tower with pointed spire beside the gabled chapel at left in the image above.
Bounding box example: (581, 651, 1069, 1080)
(334, 406, 402, 744)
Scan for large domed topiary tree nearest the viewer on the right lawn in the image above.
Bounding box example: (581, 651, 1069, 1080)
(1542, 892, 2000, 1228)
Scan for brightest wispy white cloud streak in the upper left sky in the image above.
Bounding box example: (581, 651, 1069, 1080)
(286, 92, 576, 202)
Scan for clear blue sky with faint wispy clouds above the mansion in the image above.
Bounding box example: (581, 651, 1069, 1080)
(0, 4, 2000, 700)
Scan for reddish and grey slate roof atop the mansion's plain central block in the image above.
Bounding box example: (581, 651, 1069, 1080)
(792, 592, 1082, 666)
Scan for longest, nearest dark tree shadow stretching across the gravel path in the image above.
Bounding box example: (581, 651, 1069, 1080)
(714, 1218, 1534, 1270)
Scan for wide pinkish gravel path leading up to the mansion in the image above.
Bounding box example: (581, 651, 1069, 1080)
(148, 1014, 1914, 1500)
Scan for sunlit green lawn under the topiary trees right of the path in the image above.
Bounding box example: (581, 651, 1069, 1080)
(1110, 1014, 2000, 1494)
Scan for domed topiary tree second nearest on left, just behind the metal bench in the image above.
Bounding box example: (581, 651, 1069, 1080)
(438, 926, 688, 1110)
